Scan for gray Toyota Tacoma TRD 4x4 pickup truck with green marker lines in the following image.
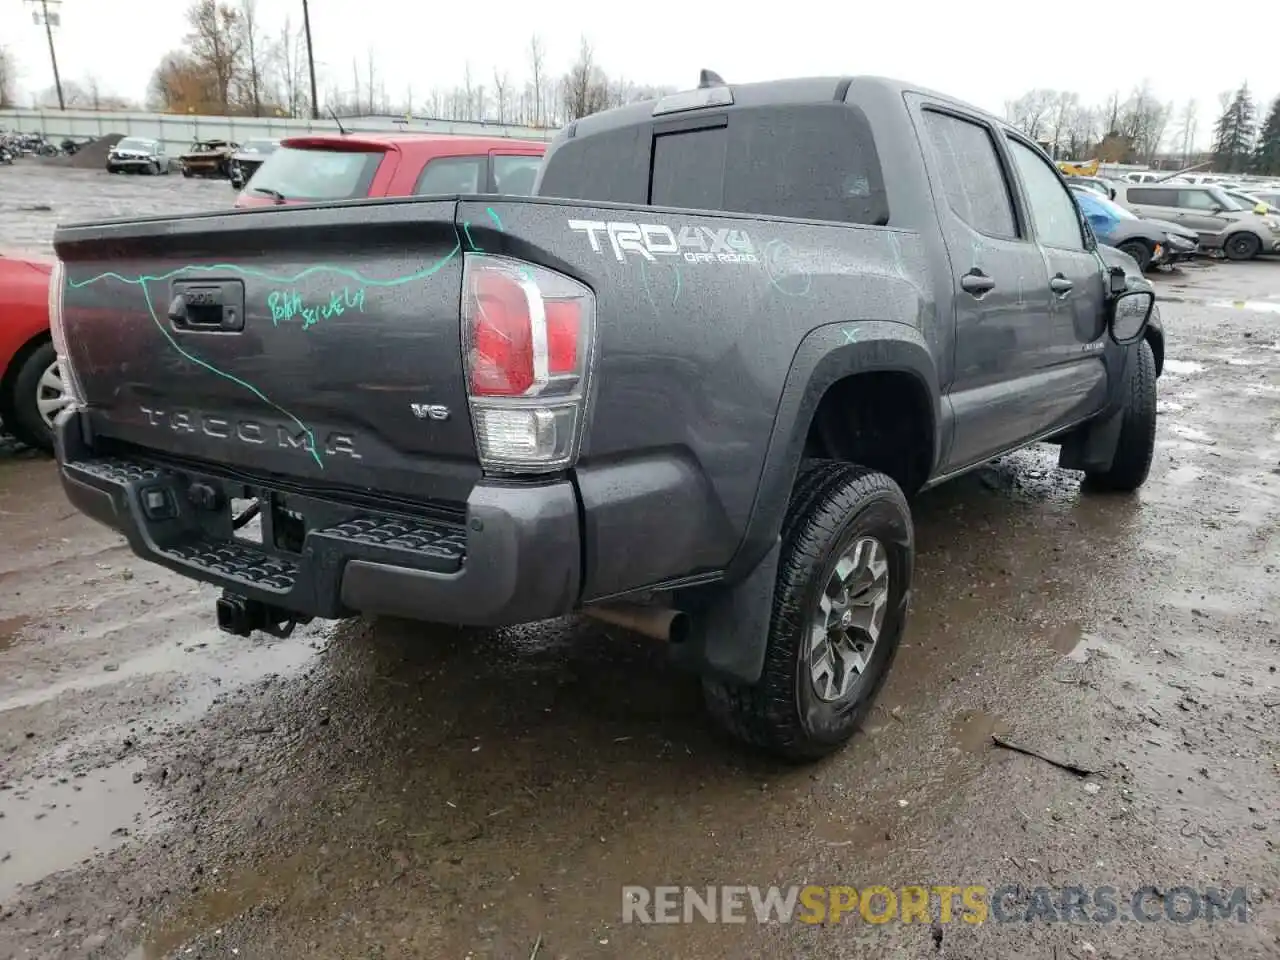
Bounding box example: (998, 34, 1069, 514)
(51, 73, 1162, 759)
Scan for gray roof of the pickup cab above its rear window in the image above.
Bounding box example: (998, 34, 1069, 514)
(561, 76, 1009, 137)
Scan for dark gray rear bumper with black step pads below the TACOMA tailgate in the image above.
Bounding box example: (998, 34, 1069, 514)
(56, 413, 581, 626)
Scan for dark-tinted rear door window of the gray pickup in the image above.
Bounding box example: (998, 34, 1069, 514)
(924, 110, 1018, 239)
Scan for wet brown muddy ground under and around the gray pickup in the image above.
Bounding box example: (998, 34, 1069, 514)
(0, 168, 1280, 960)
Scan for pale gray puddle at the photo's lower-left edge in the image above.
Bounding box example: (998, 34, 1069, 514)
(0, 758, 147, 901)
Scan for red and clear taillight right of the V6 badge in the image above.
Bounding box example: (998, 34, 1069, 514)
(462, 253, 595, 474)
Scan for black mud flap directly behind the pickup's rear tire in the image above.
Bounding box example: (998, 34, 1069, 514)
(671, 539, 782, 685)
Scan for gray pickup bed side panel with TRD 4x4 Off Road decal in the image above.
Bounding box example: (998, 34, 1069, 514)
(458, 198, 936, 599)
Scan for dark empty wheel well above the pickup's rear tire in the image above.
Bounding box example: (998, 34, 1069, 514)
(805, 371, 934, 495)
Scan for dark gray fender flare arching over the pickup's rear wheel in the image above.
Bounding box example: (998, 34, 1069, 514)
(726, 320, 950, 582)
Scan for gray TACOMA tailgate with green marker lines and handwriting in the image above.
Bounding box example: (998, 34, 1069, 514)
(55, 198, 480, 500)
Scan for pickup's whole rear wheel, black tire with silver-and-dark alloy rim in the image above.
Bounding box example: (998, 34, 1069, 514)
(704, 461, 915, 762)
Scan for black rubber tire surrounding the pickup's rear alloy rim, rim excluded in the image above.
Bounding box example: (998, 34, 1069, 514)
(703, 461, 915, 762)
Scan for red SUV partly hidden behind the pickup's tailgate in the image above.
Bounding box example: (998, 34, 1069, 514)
(236, 133, 547, 207)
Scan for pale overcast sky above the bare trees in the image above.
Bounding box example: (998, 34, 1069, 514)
(0, 0, 1280, 141)
